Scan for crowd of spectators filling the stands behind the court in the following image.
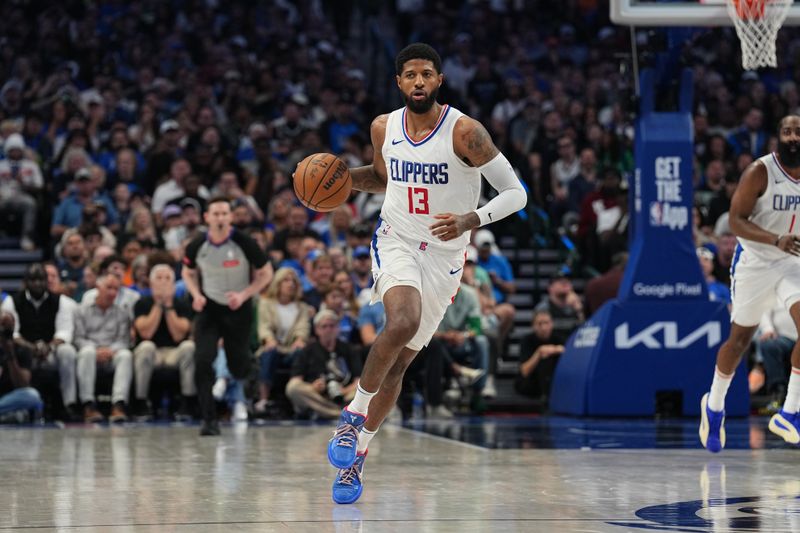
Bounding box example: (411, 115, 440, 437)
(0, 0, 800, 424)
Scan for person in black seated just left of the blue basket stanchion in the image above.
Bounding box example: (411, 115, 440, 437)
(514, 310, 565, 405)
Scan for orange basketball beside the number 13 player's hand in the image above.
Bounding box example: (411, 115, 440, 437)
(294, 153, 353, 213)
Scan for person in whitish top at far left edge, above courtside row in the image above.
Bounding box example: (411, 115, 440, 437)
(0, 133, 44, 250)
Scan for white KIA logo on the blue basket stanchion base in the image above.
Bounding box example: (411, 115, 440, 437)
(614, 321, 722, 350)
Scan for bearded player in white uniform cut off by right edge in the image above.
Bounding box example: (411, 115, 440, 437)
(700, 115, 800, 453)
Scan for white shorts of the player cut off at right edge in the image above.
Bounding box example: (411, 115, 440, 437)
(731, 250, 800, 327)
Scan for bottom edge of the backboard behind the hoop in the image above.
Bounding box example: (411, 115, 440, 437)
(610, 0, 800, 26)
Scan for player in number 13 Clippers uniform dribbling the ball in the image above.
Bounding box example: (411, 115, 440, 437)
(316, 43, 527, 503)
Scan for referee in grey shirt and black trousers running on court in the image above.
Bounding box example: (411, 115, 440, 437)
(183, 198, 273, 435)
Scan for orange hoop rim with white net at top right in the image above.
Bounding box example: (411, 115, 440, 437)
(727, 0, 793, 70)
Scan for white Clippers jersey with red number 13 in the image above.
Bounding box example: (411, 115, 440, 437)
(381, 105, 481, 251)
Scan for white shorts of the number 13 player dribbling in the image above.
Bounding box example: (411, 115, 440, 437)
(370, 222, 464, 351)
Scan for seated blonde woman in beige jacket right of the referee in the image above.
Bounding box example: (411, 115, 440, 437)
(255, 267, 314, 414)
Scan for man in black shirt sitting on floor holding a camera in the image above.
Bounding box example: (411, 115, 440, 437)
(286, 310, 362, 419)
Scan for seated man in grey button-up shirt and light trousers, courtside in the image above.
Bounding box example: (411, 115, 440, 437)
(75, 272, 133, 422)
